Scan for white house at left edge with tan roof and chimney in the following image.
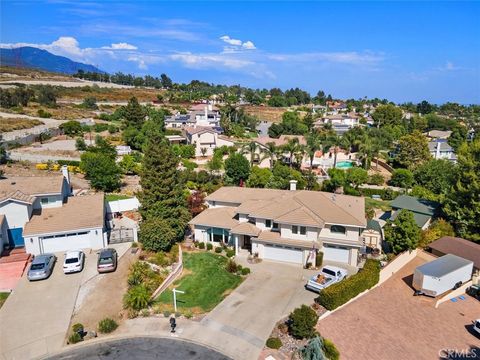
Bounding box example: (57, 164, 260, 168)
(0, 167, 107, 255)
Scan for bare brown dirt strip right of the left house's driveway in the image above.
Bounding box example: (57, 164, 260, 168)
(71, 251, 139, 330)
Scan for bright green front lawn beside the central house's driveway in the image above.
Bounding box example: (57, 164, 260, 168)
(157, 252, 242, 313)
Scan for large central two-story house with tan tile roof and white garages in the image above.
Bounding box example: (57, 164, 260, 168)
(190, 184, 367, 266)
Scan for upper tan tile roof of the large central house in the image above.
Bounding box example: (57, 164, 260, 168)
(206, 186, 367, 227)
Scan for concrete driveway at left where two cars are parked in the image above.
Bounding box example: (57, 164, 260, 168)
(0, 244, 129, 360)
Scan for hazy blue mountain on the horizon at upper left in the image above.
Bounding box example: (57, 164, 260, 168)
(0, 46, 104, 75)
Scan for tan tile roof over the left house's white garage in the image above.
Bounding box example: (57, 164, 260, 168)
(23, 193, 105, 236)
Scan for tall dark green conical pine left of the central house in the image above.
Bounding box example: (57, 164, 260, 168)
(139, 133, 190, 244)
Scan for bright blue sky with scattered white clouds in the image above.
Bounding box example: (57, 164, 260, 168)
(0, 0, 480, 104)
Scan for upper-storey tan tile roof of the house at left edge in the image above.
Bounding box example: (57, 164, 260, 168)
(0, 175, 64, 198)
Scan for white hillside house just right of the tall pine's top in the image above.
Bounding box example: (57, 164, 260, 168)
(184, 126, 235, 157)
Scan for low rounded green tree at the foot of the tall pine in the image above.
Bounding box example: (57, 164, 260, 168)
(139, 217, 176, 251)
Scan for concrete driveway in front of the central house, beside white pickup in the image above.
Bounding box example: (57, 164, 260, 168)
(201, 260, 317, 358)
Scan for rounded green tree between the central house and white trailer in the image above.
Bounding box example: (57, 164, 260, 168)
(384, 210, 420, 254)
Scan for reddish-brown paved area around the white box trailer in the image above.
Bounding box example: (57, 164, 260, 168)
(318, 256, 480, 360)
